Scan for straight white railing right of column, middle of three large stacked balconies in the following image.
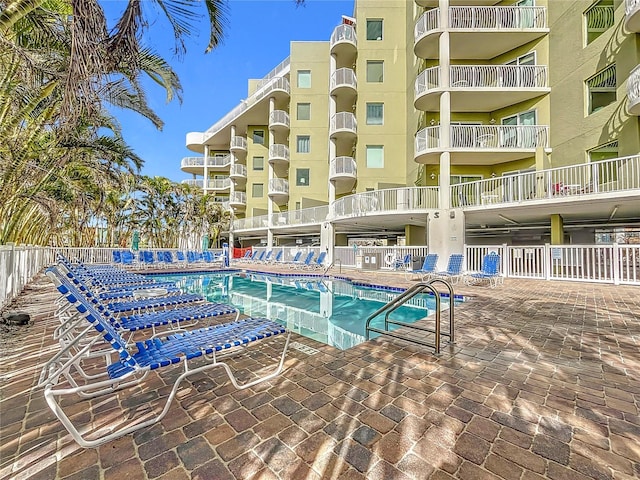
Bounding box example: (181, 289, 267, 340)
(449, 65, 549, 88)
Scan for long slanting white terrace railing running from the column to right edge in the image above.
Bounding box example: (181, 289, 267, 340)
(451, 155, 640, 207)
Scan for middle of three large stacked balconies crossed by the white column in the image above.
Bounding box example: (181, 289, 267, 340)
(414, 65, 550, 112)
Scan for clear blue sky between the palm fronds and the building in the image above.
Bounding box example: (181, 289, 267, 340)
(104, 0, 353, 182)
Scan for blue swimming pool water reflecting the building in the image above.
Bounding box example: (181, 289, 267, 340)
(154, 272, 462, 349)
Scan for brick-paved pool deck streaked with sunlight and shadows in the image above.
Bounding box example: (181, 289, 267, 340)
(0, 266, 640, 480)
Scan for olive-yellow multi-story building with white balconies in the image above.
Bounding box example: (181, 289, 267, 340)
(182, 0, 640, 262)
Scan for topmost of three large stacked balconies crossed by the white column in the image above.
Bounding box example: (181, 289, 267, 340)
(414, 6, 549, 60)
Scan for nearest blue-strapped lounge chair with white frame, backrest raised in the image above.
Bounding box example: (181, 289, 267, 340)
(40, 267, 290, 447)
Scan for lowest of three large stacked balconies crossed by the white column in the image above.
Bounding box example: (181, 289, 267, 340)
(415, 125, 549, 165)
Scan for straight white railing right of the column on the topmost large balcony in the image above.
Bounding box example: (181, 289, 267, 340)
(449, 6, 547, 30)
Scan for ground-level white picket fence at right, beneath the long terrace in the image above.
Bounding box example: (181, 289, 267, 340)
(465, 243, 640, 285)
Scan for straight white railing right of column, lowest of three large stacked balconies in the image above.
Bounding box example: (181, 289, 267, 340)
(450, 125, 549, 150)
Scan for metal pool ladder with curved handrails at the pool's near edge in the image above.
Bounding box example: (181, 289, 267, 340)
(366, 278, 455, 354)
